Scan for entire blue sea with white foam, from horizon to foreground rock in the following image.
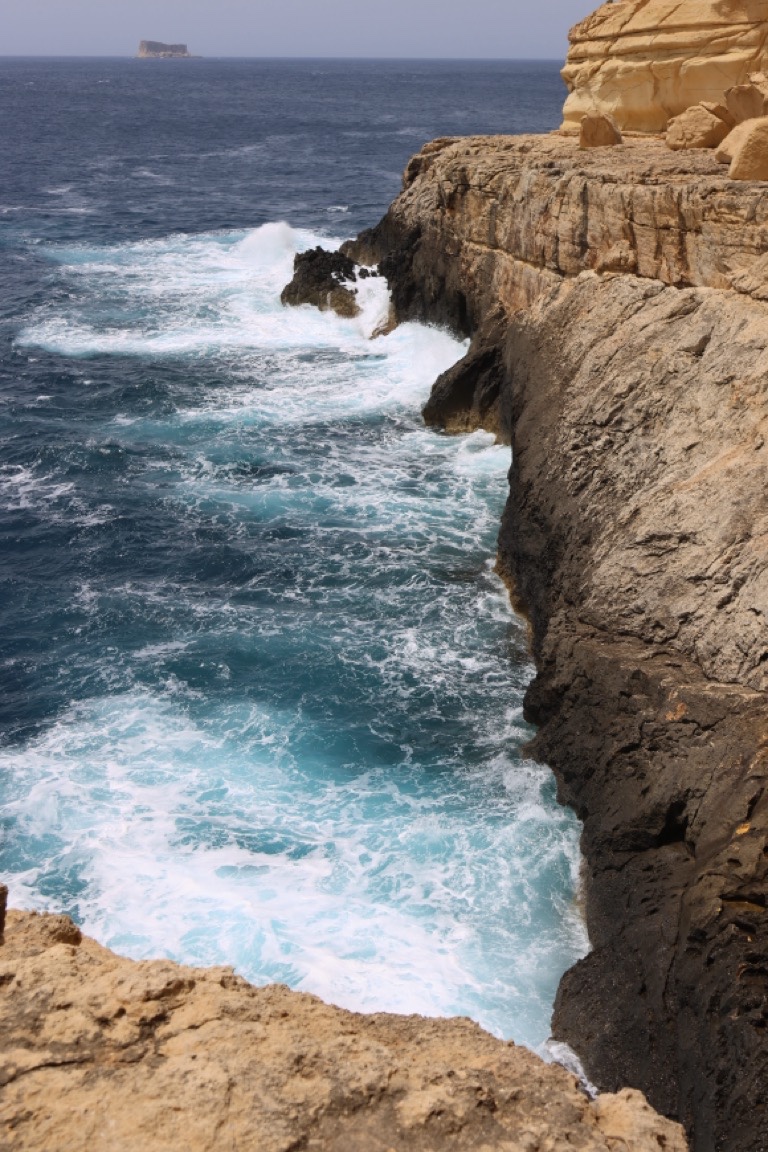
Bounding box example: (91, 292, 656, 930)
(0, 59, 586, 1047)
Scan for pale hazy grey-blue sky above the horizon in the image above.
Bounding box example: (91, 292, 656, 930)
(0, 0, 598, 59)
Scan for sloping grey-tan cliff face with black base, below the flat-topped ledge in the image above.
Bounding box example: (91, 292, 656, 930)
(500, 274, 768, 1152)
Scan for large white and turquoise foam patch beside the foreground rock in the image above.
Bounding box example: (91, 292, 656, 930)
(0, 694, 584, 1041)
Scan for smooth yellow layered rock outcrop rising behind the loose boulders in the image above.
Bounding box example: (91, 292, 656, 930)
(563, 0, 768, 132)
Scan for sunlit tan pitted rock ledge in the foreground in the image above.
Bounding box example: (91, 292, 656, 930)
(0, 911, 686, 1152)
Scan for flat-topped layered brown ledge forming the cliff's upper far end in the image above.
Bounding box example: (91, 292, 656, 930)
(343, 134, 768, 335)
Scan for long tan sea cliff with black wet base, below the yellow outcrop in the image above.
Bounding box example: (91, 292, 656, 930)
(347, 136, 768, 1152)
